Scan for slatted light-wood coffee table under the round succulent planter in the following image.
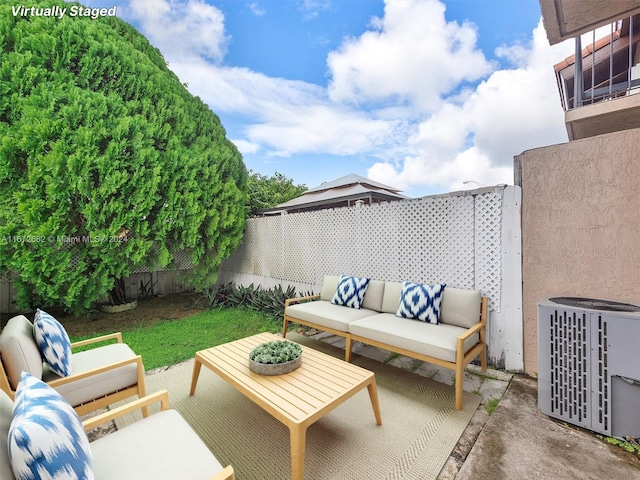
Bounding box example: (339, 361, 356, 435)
(189, 333, 382, 480)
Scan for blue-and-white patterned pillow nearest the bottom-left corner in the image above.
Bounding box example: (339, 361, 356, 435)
(8, 372, 94, 480)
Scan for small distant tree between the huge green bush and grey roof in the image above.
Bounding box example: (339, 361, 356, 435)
(247, 171, 307, 217)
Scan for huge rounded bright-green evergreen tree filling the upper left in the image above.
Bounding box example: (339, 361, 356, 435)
(0, 0, 248, 311)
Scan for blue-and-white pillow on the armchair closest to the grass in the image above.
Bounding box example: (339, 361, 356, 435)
(33, 309, 71, 377)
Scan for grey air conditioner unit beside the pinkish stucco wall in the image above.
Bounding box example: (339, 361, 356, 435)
(538, 297, 640, 438)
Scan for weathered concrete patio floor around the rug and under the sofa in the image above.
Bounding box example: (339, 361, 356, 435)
(305, 330, 640, 480)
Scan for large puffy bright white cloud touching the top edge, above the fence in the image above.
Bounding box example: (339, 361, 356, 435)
(327, 0, 491, 111)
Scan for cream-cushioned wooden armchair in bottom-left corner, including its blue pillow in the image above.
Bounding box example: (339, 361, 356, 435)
(0, 374, 235, 480)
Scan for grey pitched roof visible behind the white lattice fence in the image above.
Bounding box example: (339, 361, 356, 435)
(260, 173, 409, 215)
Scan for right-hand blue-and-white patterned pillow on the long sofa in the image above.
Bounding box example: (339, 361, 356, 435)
(396, 282, 446, 325)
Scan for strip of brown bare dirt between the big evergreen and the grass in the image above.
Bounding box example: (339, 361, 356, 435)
(34, 293, 208, 337)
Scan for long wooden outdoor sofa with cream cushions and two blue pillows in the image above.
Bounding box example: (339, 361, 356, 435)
(282, 275, 487, 410)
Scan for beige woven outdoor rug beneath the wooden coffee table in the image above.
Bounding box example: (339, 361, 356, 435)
(116, 334, 480, 480)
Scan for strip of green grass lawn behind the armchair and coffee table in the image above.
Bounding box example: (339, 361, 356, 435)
(71, 308, 282, 370)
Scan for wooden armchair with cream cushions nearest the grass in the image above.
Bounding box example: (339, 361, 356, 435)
(0, 315, 147, 416)
